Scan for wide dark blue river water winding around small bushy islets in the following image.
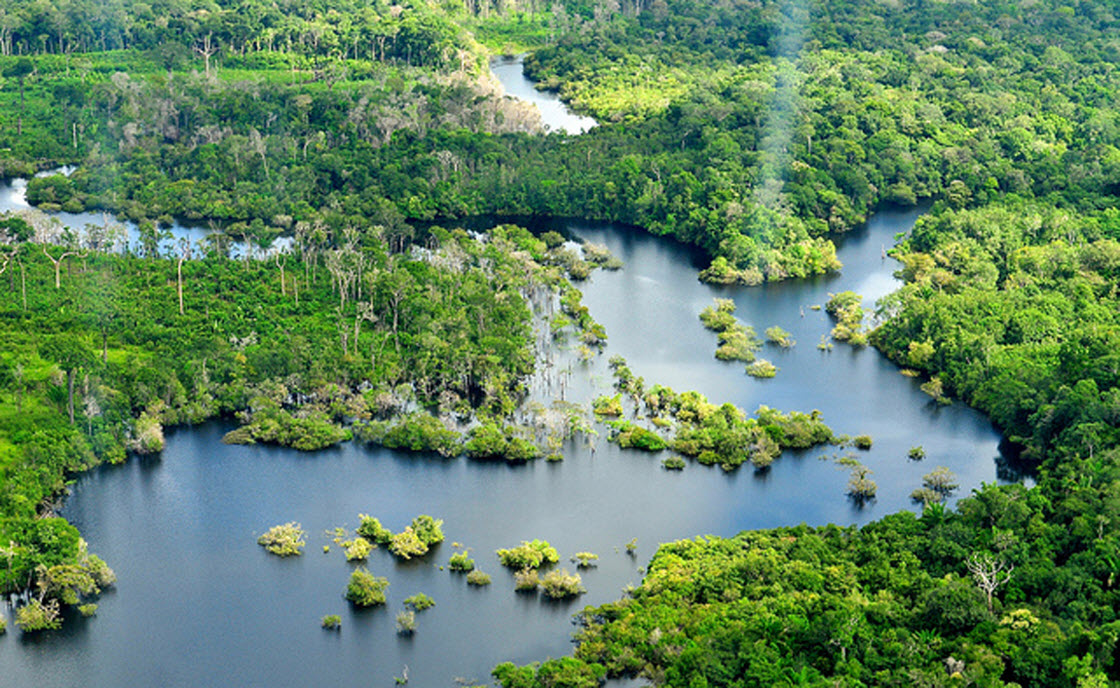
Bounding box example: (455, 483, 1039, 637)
(0, 60, 1012, 688)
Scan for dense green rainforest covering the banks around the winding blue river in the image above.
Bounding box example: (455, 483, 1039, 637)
(0, 0, 1120, 687)
